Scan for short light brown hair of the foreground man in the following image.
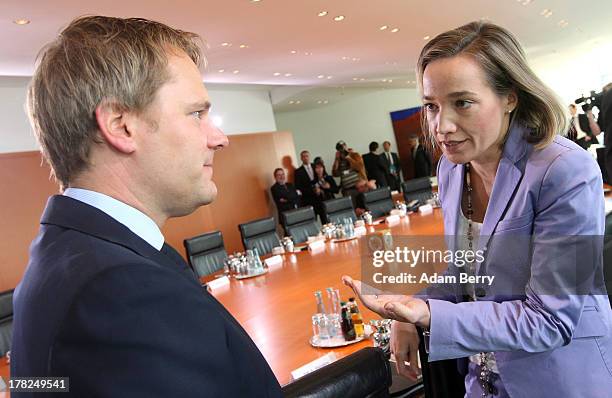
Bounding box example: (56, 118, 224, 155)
(27, 16, 203, 188)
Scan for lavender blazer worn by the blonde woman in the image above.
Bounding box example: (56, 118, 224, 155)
(429, 125, 612, 398)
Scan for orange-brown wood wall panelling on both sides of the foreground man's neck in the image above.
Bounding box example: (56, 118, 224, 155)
(0, 132, 295, 291)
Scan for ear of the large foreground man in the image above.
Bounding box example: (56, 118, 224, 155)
(95, 102, 136, 154)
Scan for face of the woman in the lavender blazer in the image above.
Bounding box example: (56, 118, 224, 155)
(423, 55, 516, 163)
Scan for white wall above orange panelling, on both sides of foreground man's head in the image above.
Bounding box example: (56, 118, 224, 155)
(0, 76, 277, 153)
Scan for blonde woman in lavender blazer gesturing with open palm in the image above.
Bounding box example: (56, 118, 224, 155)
(343, 22, 612, 398)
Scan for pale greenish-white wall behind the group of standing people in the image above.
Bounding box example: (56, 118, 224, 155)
(275, 89, 421, 172)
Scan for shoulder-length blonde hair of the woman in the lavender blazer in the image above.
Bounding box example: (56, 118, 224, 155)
(417, 22, 567, 148)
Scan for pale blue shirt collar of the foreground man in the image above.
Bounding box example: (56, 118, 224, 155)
(64, 188, 164, 250)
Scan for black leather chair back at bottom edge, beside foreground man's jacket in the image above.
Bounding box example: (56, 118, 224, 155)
(283, 347, 391, 398)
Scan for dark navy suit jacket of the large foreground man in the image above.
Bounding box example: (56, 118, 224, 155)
(11, 196, 282, 398)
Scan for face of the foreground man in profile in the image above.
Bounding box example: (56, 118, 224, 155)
(134, 53, 228, 217)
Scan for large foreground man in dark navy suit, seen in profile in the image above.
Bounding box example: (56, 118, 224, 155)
(11, 16, 282, 398)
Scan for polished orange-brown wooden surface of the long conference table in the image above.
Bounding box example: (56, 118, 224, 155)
(212, 209, 443, 385)
